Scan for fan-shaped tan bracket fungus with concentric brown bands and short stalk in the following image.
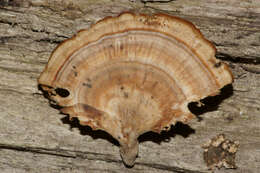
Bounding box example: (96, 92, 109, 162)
(38, 13, 233, 166)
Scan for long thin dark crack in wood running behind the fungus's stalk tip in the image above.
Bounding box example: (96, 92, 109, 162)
(0, 144, 203, 173)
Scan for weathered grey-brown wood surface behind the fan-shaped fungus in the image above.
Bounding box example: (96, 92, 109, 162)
(0, 0, 260, 173)
